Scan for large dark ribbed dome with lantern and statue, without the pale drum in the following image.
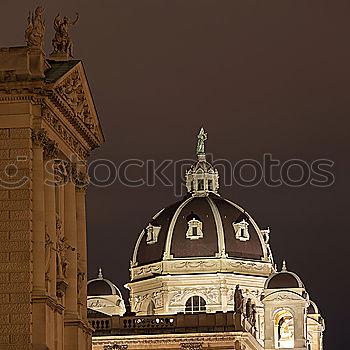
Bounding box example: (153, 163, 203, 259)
(132, 129, 272, 266)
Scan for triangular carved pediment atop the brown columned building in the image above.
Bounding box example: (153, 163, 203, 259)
(48, 61, 104, 149)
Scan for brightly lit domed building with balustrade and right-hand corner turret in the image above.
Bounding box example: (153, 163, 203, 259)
(90, 129, 324, 350)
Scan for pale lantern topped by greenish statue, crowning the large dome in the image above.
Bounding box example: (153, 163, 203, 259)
(186, 128, 219, 196)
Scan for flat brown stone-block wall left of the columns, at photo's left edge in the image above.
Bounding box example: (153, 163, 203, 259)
(0, 128, 32, 350)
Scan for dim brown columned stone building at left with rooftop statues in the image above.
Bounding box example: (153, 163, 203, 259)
(0, 7, 103, 350)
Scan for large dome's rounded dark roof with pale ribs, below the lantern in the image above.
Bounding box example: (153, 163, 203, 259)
(133, 193, 267, 265)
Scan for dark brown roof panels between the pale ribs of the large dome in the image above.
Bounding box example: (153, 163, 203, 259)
(136, 194, 264, 265)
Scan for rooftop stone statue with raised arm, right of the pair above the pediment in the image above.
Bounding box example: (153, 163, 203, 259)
(51, 13, 79, 57)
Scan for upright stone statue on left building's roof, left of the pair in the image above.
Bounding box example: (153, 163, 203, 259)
(25, 6, 45, 49)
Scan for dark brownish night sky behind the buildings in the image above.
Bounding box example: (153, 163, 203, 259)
(0, 0, 350, 350)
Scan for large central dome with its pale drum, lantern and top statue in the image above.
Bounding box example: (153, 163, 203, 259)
(126, 128, 274, 316)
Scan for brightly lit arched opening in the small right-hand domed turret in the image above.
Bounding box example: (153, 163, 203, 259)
(274, 310, 294, 349)
